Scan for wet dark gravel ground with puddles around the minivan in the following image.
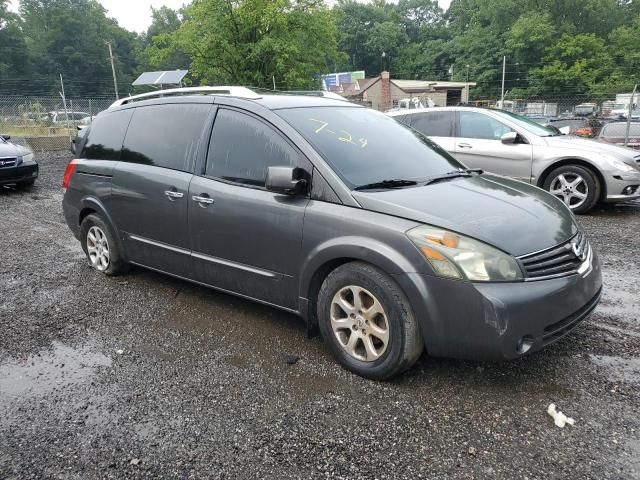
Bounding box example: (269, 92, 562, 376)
(0, 154, 640, 479)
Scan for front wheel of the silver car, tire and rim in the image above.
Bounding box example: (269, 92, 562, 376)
(543, 165, 601, 214)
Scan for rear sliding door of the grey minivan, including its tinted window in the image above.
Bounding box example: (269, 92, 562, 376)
(112, 103, 212, 277)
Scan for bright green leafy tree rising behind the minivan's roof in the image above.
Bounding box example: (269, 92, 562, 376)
(162, 0, 341, 89)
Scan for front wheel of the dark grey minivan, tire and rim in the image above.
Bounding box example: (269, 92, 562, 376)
(317, 262, 424, 380)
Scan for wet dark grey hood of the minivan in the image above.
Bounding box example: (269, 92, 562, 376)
(353, 174, 578, 256)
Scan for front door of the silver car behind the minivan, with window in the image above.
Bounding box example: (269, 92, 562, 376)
(455, 110, 533, 182)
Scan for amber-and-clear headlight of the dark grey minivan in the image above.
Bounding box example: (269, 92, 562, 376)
(407, 225, 522, 282)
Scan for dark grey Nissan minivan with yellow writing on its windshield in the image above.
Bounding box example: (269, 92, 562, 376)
(63, 89, 602, 379)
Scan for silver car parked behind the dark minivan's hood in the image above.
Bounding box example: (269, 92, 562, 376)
(388, 107, 640, 213)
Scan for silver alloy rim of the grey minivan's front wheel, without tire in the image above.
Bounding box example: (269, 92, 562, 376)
(331, 285, 389, 362)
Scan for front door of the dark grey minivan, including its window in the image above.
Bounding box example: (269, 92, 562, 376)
(189, 107, 311, 309)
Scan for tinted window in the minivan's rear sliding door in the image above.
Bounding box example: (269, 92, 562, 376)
(122, 104, 211, 172)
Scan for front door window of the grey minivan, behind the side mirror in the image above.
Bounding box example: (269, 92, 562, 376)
(205, 109, 300, 187)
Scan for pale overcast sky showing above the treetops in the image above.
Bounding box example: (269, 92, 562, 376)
(10, 0, 451, 32)
